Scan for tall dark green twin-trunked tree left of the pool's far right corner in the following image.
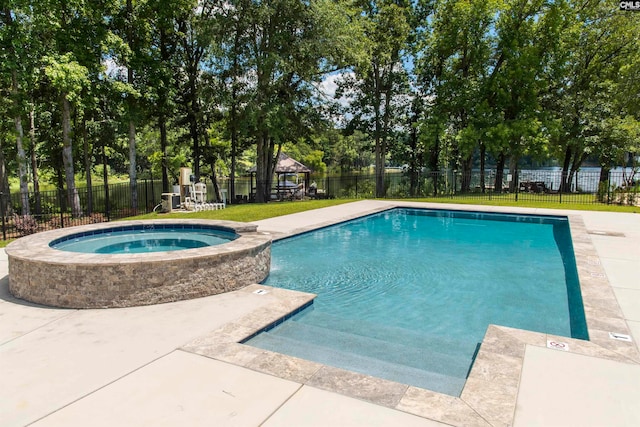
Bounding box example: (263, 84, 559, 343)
(484, 0, 558, 191)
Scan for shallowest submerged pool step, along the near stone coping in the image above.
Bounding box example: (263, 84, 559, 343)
(246, 332, 465, 396)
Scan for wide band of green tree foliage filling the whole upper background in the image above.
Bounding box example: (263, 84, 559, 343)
(0, 0, 640, 202)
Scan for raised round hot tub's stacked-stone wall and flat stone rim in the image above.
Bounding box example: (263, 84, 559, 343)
(5, 219, 271, 308)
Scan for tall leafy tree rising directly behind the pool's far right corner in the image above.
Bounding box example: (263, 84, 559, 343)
(544, 0, 638, 191)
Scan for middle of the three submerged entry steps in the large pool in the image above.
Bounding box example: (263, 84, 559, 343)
(270, 322, 471, 378)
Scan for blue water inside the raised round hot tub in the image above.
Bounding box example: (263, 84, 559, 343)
(49, 224, 237, 254)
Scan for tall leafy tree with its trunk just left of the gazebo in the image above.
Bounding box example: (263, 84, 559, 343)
(231, 0, 361, 202)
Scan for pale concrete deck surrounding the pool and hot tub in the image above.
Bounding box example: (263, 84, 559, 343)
(0, 201, 640, 426)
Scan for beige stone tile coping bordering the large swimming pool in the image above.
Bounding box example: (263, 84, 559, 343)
(183, 203, 640, 427)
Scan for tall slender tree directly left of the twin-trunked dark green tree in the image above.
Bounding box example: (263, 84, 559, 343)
(419, 0, 500, 191)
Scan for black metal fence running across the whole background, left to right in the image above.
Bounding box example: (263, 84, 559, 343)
(0, 169, 640, 240)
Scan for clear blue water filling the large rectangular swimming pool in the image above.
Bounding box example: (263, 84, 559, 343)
(247, 209, 588, 396)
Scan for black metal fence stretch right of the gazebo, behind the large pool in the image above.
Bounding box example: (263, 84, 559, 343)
(316, 170, 640, 205)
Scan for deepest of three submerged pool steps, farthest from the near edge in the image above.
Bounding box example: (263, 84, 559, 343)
(291, 307, 476, 357)
